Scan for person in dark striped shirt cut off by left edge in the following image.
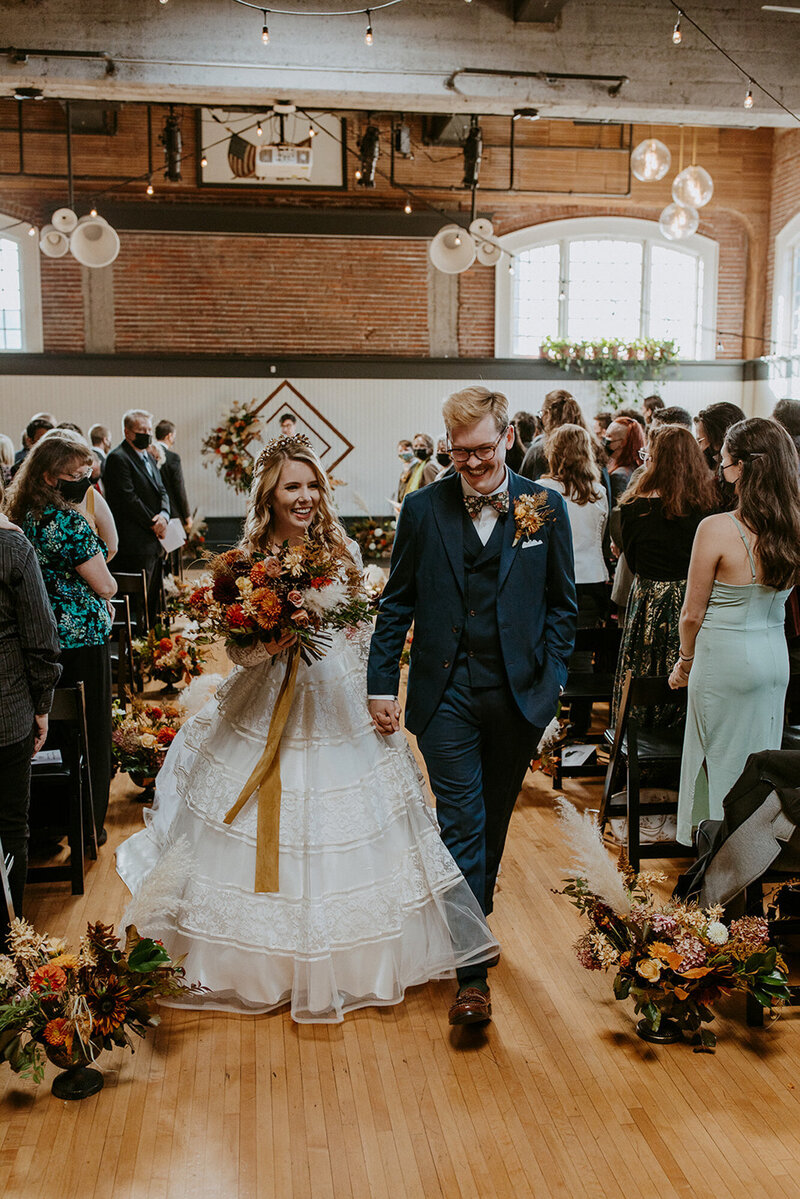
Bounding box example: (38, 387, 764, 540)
(0, 517, 61, 942)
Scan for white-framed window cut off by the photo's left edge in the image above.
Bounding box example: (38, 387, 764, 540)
(0, 213, 42, 354)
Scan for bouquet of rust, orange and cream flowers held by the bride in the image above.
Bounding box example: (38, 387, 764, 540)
(190, 537, 371, 658)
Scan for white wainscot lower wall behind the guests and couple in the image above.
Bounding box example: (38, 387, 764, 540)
(0, 363, 753, 517)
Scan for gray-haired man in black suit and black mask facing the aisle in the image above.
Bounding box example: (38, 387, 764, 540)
(103, 409, 169, 623)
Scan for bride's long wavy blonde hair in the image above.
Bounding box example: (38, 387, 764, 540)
(241, 438, 347, 554)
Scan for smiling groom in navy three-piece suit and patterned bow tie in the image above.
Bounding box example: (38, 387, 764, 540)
(367, 387, 577, 1024)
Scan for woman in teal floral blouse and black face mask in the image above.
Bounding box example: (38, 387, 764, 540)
(6, 430, 116, 844)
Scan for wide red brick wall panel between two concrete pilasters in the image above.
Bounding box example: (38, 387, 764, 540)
(114, 234, 428, 356)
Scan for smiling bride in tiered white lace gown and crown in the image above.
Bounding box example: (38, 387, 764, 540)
(116, 436, 499, 1023)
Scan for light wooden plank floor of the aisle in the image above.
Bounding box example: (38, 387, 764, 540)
(0, 705, 800, 1199)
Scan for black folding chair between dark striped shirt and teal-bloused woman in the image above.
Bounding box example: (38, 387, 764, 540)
(28, 682, 97, 896)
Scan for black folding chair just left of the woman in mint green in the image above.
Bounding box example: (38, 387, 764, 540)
(600, 670, 691, 870)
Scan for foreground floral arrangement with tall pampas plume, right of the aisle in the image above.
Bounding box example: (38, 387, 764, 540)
(557, 800, 789, 1053)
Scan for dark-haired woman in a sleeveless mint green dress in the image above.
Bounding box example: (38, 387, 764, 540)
(669, 417, 800, 845)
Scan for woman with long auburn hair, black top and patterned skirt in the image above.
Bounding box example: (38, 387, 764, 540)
(612, 426, 716, 725)
